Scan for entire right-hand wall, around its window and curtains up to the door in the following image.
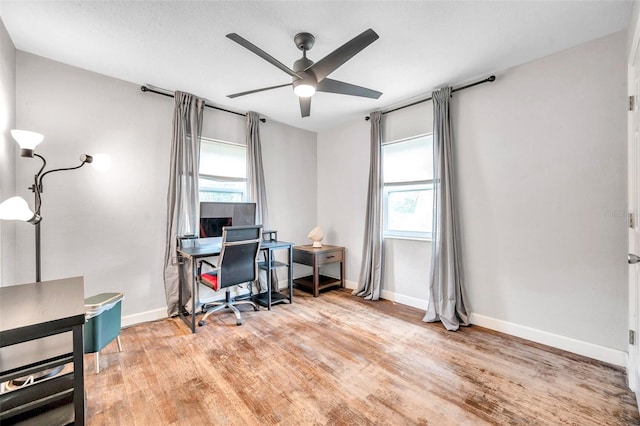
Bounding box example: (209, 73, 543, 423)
(318, 33, 627, 364)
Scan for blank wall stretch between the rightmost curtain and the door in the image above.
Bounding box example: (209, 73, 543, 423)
(452, 32, 628, 351)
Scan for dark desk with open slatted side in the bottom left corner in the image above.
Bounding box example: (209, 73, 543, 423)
(0, 277, 85, 425)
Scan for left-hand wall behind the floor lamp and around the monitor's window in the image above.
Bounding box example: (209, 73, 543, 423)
(15, 51, 317, 323)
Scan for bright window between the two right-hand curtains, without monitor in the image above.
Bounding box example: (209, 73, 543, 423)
(382, 135, 433, 239)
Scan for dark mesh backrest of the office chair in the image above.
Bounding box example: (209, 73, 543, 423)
(218, 226, 262, 288)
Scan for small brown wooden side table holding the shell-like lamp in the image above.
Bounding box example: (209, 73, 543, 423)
(293, 244, 344, 297)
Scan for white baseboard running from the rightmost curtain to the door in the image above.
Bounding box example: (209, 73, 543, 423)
(469, 313, 627, 367)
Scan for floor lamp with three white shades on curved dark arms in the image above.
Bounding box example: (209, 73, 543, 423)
(0, 130, 110, 282)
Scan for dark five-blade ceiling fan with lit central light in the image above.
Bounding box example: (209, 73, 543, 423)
(227, 28, 382, 117)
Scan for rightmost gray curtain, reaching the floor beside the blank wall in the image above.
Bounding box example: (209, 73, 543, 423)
(423, 87, 469, 331)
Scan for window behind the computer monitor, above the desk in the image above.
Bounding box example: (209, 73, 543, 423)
(198, 138, 247, 202)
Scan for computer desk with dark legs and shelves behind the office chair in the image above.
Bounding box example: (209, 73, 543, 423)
(178, 237, 293, 333)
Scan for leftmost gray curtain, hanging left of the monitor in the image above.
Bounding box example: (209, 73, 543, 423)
(164, 92, 205, 316)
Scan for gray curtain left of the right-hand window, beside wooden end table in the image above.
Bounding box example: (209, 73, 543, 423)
(353, 111, 382, 300)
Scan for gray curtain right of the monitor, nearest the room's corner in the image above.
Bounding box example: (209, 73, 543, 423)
(245, 111, 278, 291)
